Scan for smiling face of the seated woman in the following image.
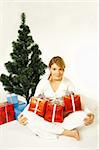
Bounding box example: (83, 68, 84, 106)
(49, 63, 64, 80)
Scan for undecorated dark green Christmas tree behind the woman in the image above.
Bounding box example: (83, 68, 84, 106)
(0, 13, 47, 103)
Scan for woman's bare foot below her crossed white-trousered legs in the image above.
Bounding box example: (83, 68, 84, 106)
(61, 129, 80, 140)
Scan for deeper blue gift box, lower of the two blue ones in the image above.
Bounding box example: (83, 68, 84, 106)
(14, 101, 27, 119)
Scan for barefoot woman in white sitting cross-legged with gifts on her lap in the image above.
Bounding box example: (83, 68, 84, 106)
(18, 56, 94, 140)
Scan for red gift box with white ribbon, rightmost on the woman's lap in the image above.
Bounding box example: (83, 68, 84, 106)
(63, 94, 82, 112)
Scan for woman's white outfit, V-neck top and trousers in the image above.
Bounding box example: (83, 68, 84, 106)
(19, 77, 91, 138)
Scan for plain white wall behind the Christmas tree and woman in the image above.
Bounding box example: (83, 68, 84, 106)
(0, 0, 98, 100)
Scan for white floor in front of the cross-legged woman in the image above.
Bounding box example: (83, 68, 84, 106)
(0, 120, 97, 150)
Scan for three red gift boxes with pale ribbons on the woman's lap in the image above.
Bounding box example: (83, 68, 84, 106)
(28, 94, 82, 122)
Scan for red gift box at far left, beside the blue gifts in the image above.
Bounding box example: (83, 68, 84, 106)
(0, 102, 15, 125)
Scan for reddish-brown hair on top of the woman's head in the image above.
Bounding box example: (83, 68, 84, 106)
(49, 56, 65, 71)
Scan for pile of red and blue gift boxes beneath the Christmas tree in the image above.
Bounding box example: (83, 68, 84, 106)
(0, 93, 27, 125)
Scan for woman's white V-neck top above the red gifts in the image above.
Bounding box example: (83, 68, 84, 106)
(34, 77, 75, 97)
